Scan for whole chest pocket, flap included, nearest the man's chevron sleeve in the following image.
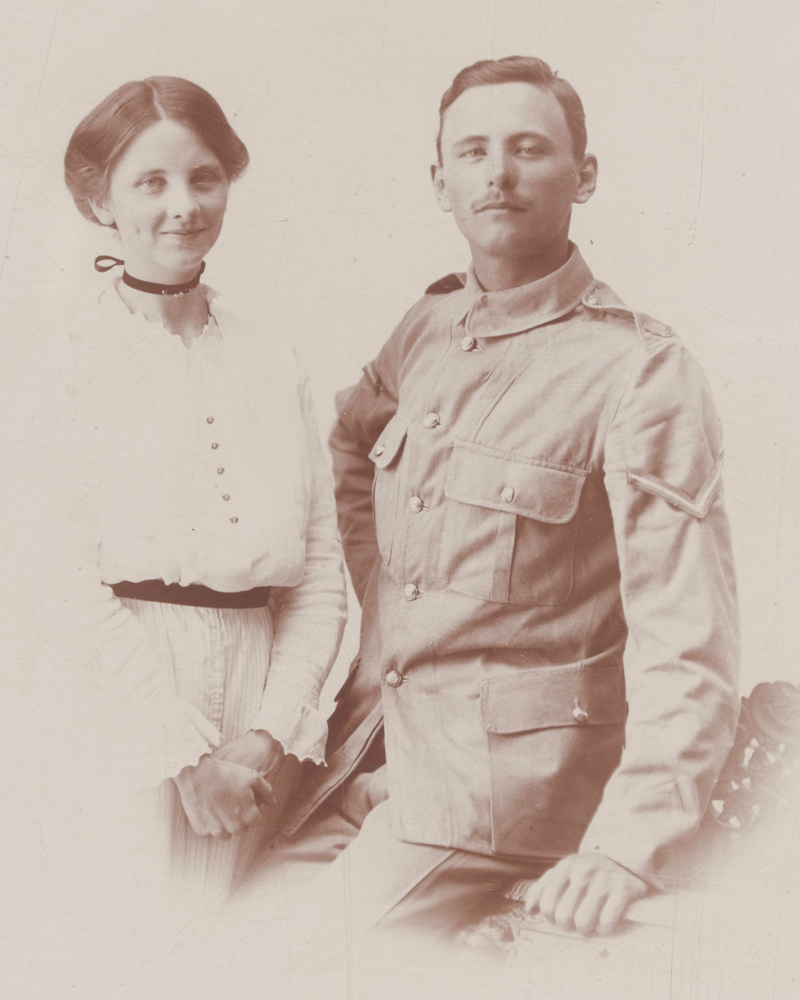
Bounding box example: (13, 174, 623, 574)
(439, 441, 587, 605)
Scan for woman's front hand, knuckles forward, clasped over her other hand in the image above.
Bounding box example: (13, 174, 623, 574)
(173, 756, 275, 840)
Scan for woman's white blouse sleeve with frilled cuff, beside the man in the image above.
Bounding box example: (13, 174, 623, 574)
(251, 384, 347, 764)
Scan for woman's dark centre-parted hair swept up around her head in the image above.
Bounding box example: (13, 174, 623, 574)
(64, 76, 249, 225)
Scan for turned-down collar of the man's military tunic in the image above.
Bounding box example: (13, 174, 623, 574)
(447, 243, 594, 337)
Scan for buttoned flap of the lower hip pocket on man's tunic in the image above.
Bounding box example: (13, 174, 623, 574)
(480, 662, 626, 733)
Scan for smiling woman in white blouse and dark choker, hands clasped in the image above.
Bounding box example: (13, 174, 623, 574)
(3, 77, 346, 928)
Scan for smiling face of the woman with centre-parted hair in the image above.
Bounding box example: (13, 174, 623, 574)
(92, 120, 228, 284)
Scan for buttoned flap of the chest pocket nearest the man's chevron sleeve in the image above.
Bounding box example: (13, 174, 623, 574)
(444, 441, 588, 524)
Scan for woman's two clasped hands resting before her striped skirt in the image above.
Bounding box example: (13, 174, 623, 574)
(174, 730, 283, 840)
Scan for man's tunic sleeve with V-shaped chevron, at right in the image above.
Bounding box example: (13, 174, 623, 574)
(581, 341, 739, 885)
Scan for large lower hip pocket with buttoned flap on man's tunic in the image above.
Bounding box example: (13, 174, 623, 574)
(481, 649, 626, 857)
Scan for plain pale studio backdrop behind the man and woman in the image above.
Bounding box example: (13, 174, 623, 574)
(0, 0, 800, 992)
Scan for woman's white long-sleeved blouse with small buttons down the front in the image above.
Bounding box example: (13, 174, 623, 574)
(3, 279, 346, 781)
